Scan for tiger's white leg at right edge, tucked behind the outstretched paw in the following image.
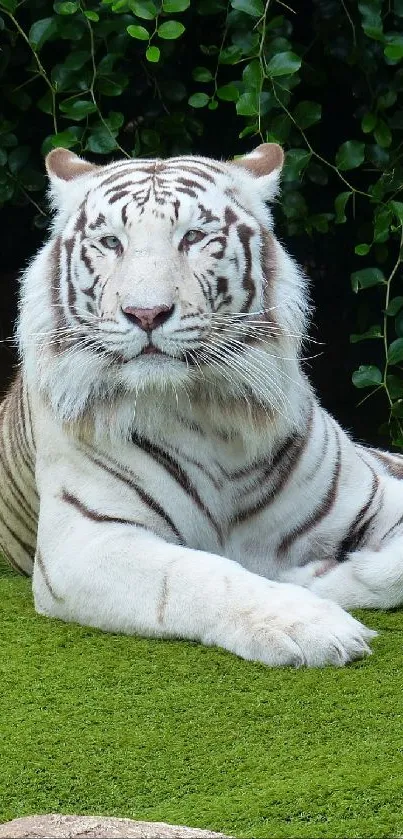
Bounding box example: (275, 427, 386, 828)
(284, 536, 403, 609)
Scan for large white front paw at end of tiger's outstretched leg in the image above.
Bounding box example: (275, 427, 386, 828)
(216, 585, 377, 667)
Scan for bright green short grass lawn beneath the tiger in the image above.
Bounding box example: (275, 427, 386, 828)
(0, 556, 403, 839)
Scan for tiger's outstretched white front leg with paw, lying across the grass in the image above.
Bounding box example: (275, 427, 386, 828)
(33, 492, 375, 666)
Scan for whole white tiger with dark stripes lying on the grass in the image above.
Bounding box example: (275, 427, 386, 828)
(0, 144, 403, 666)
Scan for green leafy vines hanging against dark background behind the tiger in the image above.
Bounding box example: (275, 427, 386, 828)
(0, 0, 403, 448)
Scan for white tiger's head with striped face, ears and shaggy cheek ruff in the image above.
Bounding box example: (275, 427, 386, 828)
(19, 144, 306, 420)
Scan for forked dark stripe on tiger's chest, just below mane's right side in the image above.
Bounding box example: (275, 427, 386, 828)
(231, 403, 314, 525)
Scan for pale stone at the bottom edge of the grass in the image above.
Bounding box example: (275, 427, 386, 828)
(0, 814, 228, 839)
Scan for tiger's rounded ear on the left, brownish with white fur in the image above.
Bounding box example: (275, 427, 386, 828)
(45, 148, 98, 209)
